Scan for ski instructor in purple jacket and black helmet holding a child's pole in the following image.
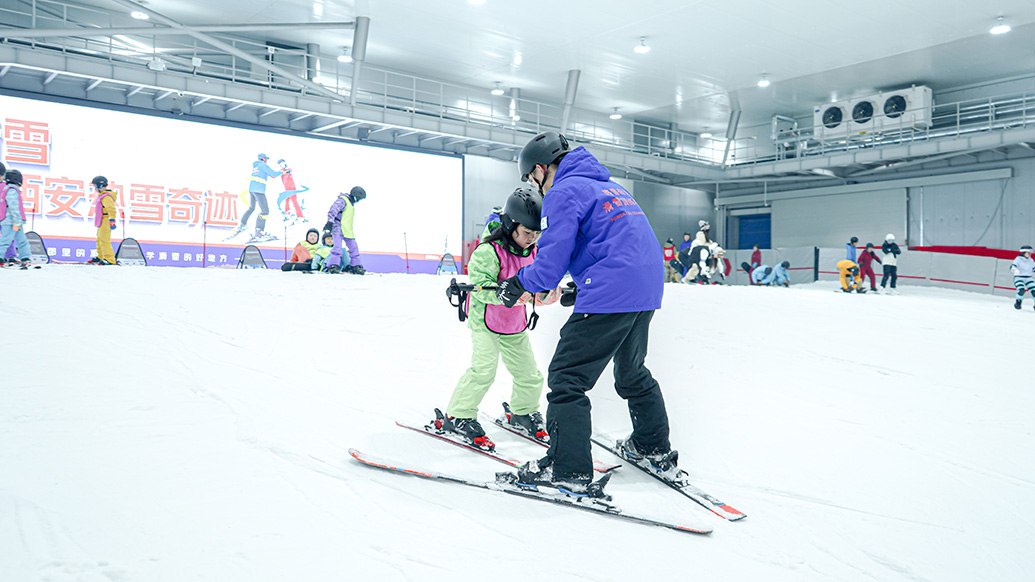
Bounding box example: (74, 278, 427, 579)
(497, 132, 676, 493)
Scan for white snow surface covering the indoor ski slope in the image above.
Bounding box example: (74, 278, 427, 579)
(0, 265, 1035, 582)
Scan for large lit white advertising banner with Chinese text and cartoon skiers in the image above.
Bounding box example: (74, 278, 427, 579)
(0, 95, 463, 272)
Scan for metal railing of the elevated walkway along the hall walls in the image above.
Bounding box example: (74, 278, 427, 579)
(6, 0, 1035, 166)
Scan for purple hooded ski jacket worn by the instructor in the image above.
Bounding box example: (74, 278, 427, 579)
(518, 147, 664, 313)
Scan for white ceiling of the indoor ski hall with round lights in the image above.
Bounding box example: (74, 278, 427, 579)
(22, 0, 1035, 133)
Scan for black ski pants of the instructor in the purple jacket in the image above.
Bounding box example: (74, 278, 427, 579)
(546, 311, 671, 479)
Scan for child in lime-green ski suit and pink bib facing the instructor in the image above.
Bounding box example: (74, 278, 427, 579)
(435, 187, 556, 450)
